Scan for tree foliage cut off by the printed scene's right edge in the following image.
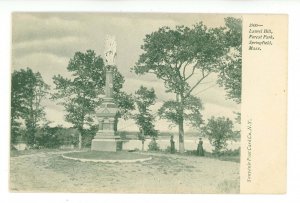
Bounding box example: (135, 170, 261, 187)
(218, 17, 242, 103)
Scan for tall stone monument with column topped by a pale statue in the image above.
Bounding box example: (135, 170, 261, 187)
(91, 36, 122, 152)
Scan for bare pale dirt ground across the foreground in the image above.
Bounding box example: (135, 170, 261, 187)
(10, 152, 239, 193)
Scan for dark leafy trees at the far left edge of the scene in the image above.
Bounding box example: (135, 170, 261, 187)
(11, 68, 49, 145)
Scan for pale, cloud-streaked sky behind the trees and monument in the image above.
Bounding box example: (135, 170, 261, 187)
(12, 13, 240, 131)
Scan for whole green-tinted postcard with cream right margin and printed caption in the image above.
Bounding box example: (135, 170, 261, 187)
(9, 12, 288, 194)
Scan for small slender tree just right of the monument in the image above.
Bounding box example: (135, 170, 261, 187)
(133, 86, 158, 147)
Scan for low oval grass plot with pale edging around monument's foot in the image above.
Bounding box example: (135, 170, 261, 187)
(64, 151, 149, 160)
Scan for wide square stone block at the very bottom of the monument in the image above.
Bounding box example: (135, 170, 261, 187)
(91, 138, 122, 152)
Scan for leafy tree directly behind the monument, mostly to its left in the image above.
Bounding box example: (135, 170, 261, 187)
(52, 50, 130, 148)
